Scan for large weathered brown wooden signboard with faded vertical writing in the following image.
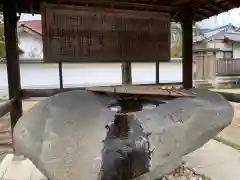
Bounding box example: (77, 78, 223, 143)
(42, 4, 170, 62)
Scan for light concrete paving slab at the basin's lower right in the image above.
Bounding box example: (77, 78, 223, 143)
(183, 140, 240, 180)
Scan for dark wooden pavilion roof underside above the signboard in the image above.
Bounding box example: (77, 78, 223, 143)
(0, 0, 240, 21)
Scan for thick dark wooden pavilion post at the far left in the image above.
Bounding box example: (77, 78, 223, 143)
(3, 1, 22, 128)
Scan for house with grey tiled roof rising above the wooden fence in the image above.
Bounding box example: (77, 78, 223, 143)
(193, 24, 240, 60)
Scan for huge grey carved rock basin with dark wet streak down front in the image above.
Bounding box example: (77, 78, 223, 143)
(14, 89, 233, 180)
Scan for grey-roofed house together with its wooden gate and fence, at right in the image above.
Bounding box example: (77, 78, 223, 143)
(193, 24, 240, 83)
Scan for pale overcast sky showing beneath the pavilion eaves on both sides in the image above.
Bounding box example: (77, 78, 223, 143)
(20, 8, 240, 28)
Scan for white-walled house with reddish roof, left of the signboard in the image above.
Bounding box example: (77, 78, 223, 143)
(18, 20, 43, 61)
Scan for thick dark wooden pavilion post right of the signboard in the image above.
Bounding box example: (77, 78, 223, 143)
(181, 14, 193, 89)
